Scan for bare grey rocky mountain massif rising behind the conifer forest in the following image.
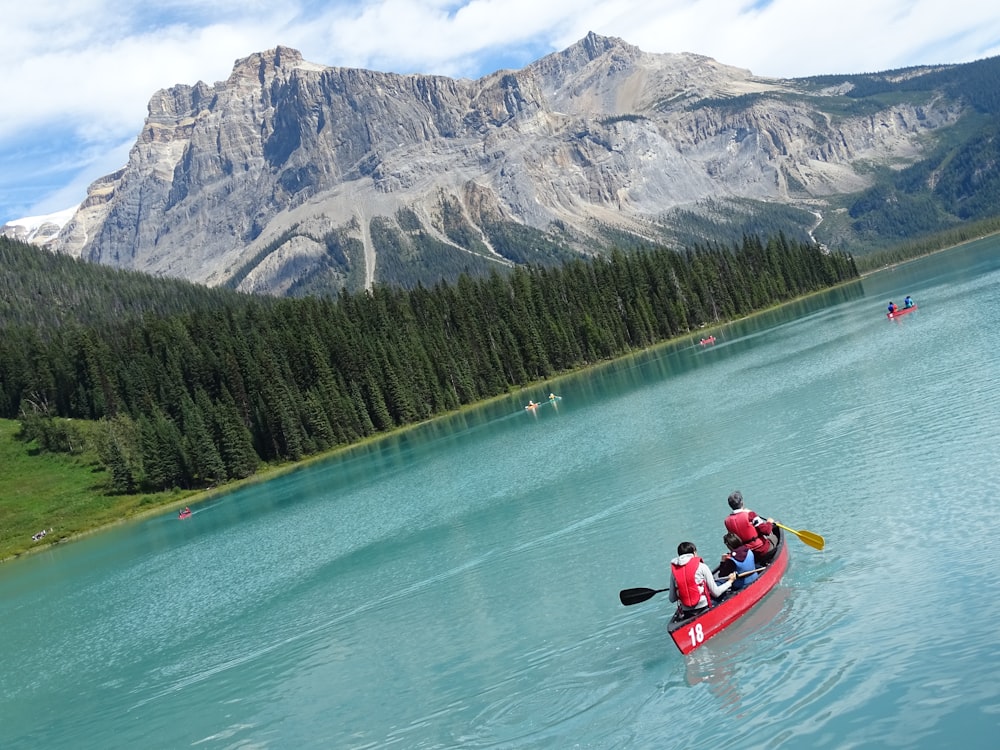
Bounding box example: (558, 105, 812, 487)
(37, 34, 960, 294)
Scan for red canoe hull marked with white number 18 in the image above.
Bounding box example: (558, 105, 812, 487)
(667, 527, 788, 654)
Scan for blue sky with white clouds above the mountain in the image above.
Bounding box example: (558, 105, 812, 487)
(0, 0, 1000, 224)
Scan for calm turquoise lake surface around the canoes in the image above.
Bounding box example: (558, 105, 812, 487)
(0, 239, 1000, 750)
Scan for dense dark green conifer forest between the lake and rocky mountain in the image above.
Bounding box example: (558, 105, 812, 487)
(0, 234, 858, 557)
